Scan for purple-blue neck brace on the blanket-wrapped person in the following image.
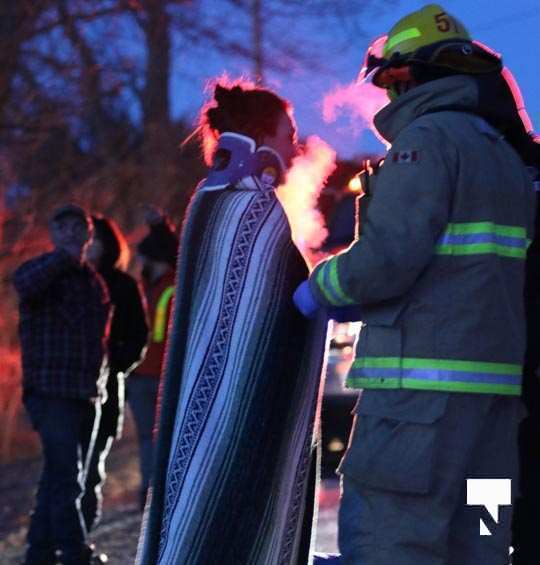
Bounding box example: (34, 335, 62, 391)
(205, 132, 286, 189)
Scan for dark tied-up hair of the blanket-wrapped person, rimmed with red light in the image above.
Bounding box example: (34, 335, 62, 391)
(199, 82, 292, 163)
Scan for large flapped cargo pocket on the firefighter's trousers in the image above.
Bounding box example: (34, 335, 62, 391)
(339, 390, 448, 494)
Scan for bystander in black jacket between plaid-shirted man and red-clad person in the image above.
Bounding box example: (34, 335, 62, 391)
(81, 216, 148, 531)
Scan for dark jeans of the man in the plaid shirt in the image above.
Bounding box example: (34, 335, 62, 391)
(24, 394, 99, 565)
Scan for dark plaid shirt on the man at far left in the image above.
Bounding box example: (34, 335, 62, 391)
(14, 250, 111, 399)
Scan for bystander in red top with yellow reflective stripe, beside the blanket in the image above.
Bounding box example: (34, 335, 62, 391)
(128, 207, 178, 510)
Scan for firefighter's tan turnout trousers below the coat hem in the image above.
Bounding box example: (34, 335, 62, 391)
(338, 390, 524, 565)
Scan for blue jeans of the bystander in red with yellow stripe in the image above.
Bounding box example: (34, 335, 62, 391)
(127, 374, 159, 503)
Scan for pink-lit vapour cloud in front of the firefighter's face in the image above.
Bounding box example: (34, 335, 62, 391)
(323, 81, 389, 146)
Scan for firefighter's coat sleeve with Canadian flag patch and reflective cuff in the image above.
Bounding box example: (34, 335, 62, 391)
(310, 119, 457, 306)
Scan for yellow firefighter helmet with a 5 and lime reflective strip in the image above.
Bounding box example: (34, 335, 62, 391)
(359, 4, 502, 91)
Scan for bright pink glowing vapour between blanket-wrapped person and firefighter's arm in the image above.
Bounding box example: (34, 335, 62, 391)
(276, 136, 336, 267)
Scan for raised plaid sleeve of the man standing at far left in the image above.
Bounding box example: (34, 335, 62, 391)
(13, 250, 77, 300)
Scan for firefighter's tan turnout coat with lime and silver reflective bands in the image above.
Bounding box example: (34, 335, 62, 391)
(310, 72, 535, 395)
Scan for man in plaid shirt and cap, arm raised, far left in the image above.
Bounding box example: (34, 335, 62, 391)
(14, 205, 111, 565)
